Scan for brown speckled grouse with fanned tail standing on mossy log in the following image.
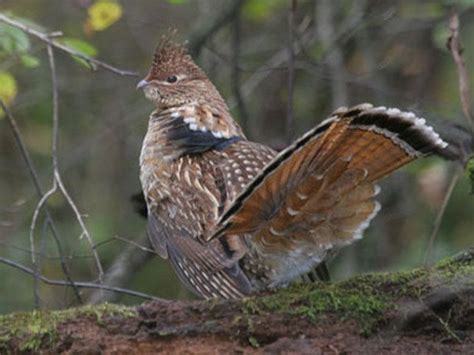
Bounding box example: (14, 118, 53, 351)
(137, 36, 448, 299)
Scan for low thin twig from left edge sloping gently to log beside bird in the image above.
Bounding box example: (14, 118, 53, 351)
(0, 257, 165, 303)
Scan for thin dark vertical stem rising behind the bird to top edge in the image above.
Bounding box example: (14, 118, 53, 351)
(285, 0, 297, 144)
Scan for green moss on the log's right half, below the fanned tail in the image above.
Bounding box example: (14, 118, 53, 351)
(242, 251, 474, 334)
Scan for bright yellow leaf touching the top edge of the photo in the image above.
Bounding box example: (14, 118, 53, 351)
(86, 0, 122, 31)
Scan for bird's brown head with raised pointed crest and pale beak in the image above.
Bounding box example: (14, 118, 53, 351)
(137, 37, 220, 110)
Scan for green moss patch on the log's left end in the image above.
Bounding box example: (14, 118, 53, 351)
(0, 303, 136, 352)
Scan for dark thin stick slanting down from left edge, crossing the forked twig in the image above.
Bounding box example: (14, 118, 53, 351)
(0, 100, 83, 303)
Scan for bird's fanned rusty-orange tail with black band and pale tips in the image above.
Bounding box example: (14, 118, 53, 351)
(206, 104, 446, 253)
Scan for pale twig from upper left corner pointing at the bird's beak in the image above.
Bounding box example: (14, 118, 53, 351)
(0, 13, 138, 76)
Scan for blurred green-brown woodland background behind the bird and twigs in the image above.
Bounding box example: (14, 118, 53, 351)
(0, 0, 474, 313)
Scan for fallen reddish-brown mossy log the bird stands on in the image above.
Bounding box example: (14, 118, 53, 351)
(0, 249, 474, 355)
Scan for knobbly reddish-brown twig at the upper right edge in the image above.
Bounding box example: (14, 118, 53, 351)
(446, 13, 474, 132)
